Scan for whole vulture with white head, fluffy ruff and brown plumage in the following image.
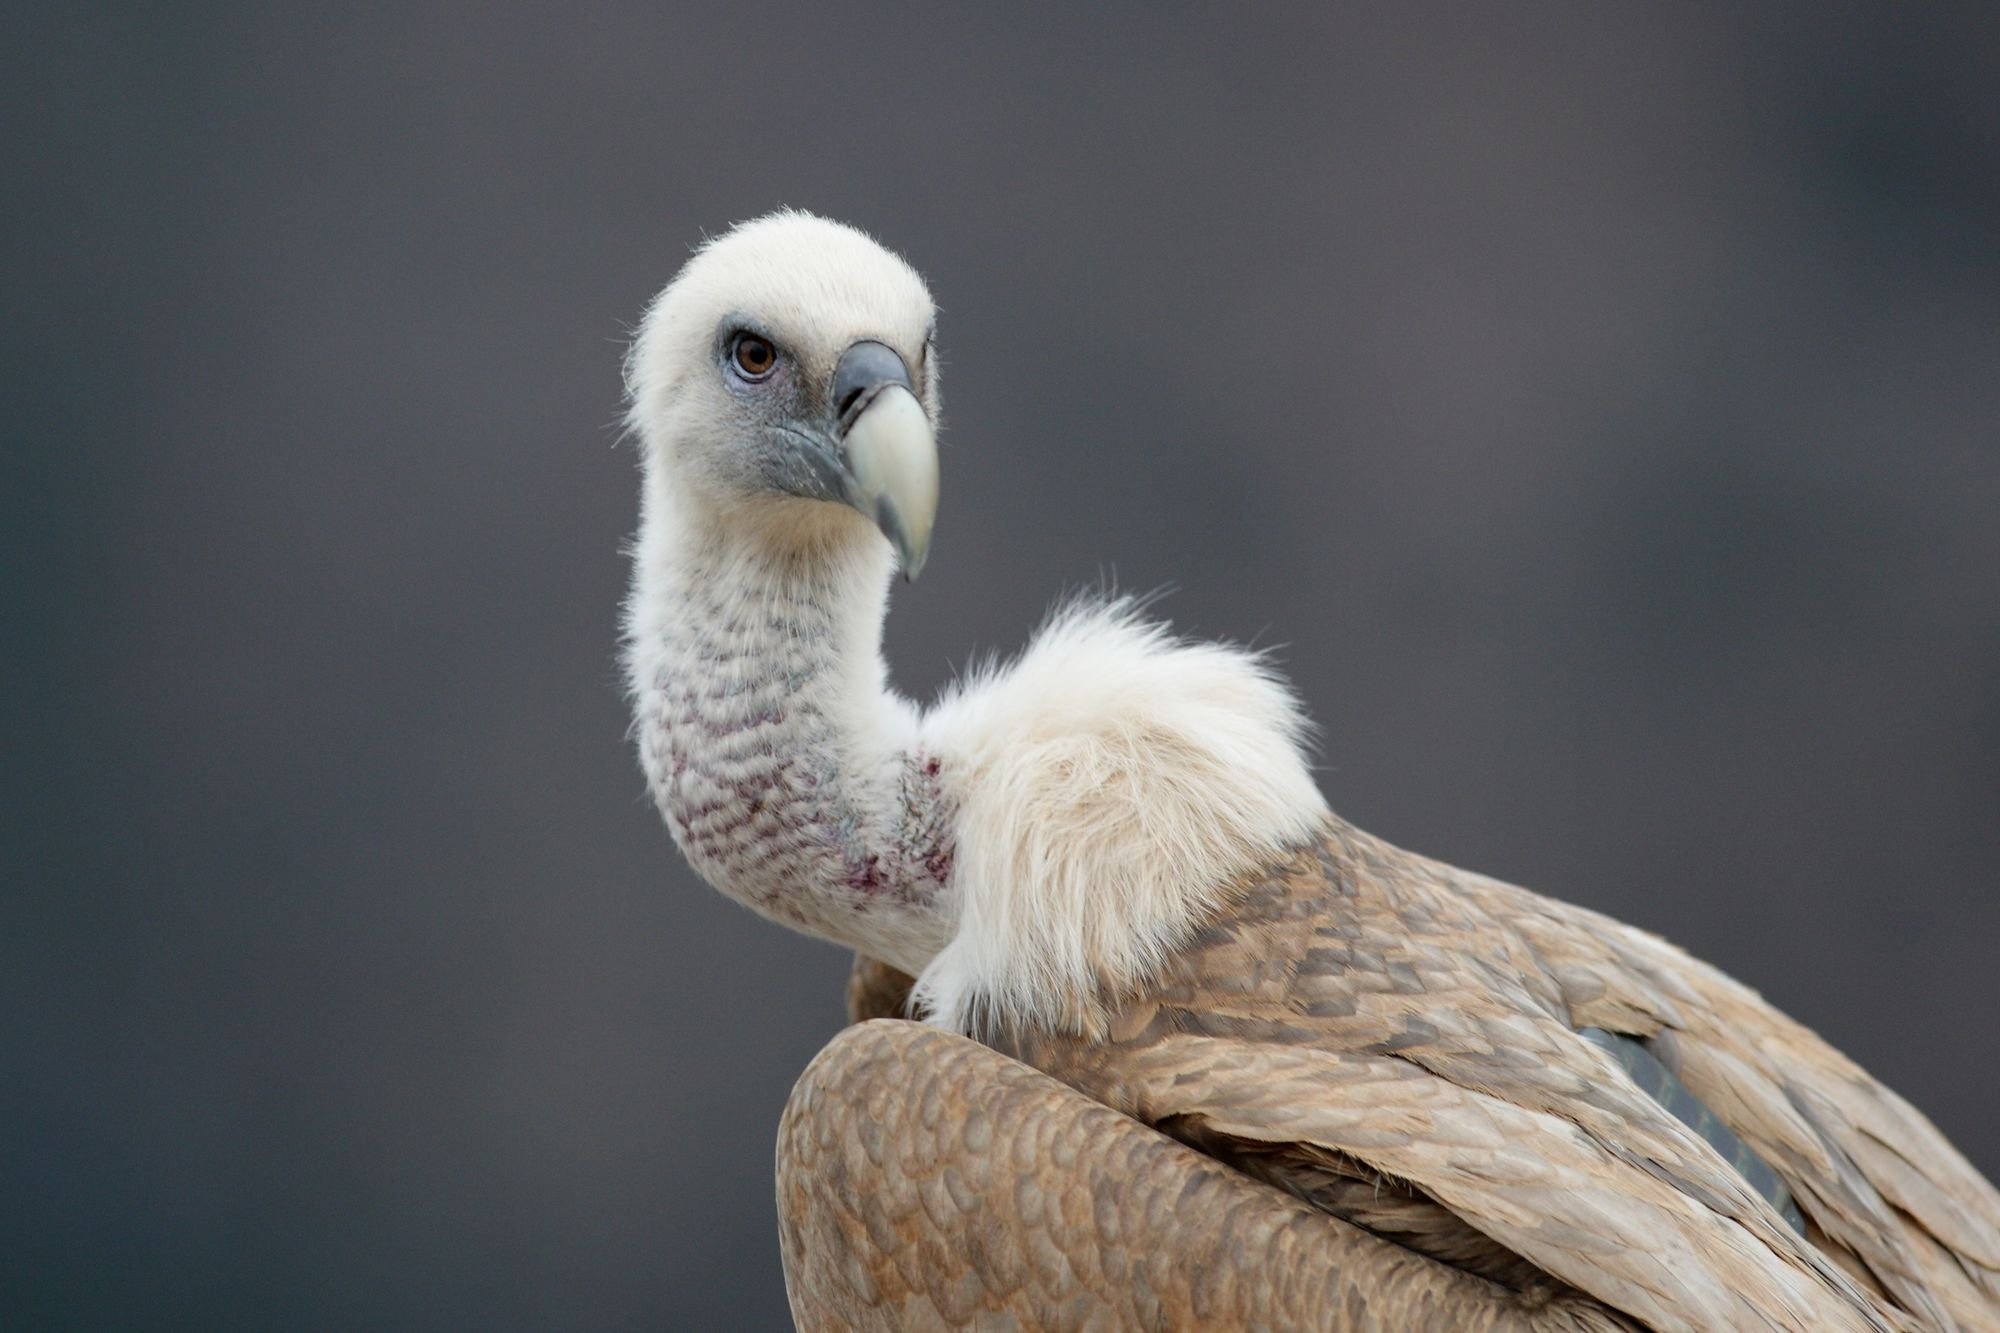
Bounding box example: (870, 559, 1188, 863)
(626, 214, 2000, 1329)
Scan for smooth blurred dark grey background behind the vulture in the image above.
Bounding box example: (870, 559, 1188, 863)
(0, 2, 2000, 1329)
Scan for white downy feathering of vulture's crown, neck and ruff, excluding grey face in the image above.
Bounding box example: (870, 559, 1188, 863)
(626, 214, 1326, 1031)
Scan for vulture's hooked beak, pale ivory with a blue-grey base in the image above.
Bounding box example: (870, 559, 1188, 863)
(832, 340, 938, 580)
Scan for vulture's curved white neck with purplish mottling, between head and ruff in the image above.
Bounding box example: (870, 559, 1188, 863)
(628, 490, 952, 975)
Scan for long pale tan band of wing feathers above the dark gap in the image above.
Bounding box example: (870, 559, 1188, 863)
(1016, 1020, 1892, 1329)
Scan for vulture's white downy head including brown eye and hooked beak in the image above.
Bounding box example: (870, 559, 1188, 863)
(628, 212, 938, 578)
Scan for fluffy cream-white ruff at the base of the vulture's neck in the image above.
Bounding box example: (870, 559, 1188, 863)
(916, 600, 1326, 1033)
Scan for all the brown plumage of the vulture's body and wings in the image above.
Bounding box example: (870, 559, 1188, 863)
(780, 821, 2000, 1329)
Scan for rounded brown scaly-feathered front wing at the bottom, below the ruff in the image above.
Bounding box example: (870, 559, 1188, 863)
(778, 1023, 1638, 1333)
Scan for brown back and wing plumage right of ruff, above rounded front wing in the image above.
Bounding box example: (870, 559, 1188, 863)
(832, 823, 2000, 1329)
